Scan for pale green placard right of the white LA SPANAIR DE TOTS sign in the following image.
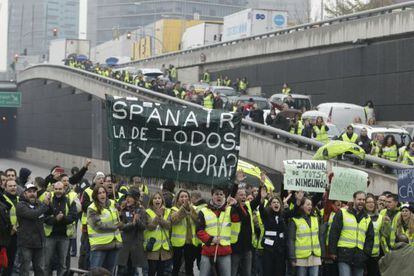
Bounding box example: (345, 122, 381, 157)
(329, 167, 368, 201)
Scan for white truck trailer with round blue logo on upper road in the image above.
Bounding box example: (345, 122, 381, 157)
(223, 9, 287, 42)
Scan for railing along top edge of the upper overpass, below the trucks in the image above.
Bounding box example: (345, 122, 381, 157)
(118, 1, 414, 67)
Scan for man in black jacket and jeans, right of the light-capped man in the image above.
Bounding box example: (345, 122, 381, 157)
(45, 181, 77, 276)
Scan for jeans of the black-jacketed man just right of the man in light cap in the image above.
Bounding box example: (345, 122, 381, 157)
(45, 237, 69, 276)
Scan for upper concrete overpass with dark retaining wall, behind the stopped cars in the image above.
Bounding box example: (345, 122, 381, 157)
(117, 2, 414, 121)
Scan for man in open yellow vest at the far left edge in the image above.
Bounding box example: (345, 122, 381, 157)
(3, 180, 19, 275)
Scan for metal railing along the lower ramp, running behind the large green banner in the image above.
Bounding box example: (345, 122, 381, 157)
(18, 64, 412, 172)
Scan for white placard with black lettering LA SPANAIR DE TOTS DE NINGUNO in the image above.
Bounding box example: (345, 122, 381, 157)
(283, 160, 327, 193)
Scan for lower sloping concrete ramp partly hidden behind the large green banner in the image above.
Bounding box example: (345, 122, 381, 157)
(16, 65, 408, 193)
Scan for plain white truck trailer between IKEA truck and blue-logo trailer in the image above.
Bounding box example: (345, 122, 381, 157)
(181, 22, 223, 50)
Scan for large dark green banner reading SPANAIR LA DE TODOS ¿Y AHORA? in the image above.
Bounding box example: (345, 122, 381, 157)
(106, 96, 242, 185)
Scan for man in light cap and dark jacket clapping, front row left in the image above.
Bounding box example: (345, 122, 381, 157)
(16, 183, 50, 276)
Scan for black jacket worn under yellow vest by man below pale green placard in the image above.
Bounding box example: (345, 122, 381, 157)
(328, 208, 375, 268)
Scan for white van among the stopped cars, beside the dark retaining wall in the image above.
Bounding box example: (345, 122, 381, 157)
(316, 103, 367, 131)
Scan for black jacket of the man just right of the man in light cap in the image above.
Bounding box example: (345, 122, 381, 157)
(45, 196, 77, 237)
